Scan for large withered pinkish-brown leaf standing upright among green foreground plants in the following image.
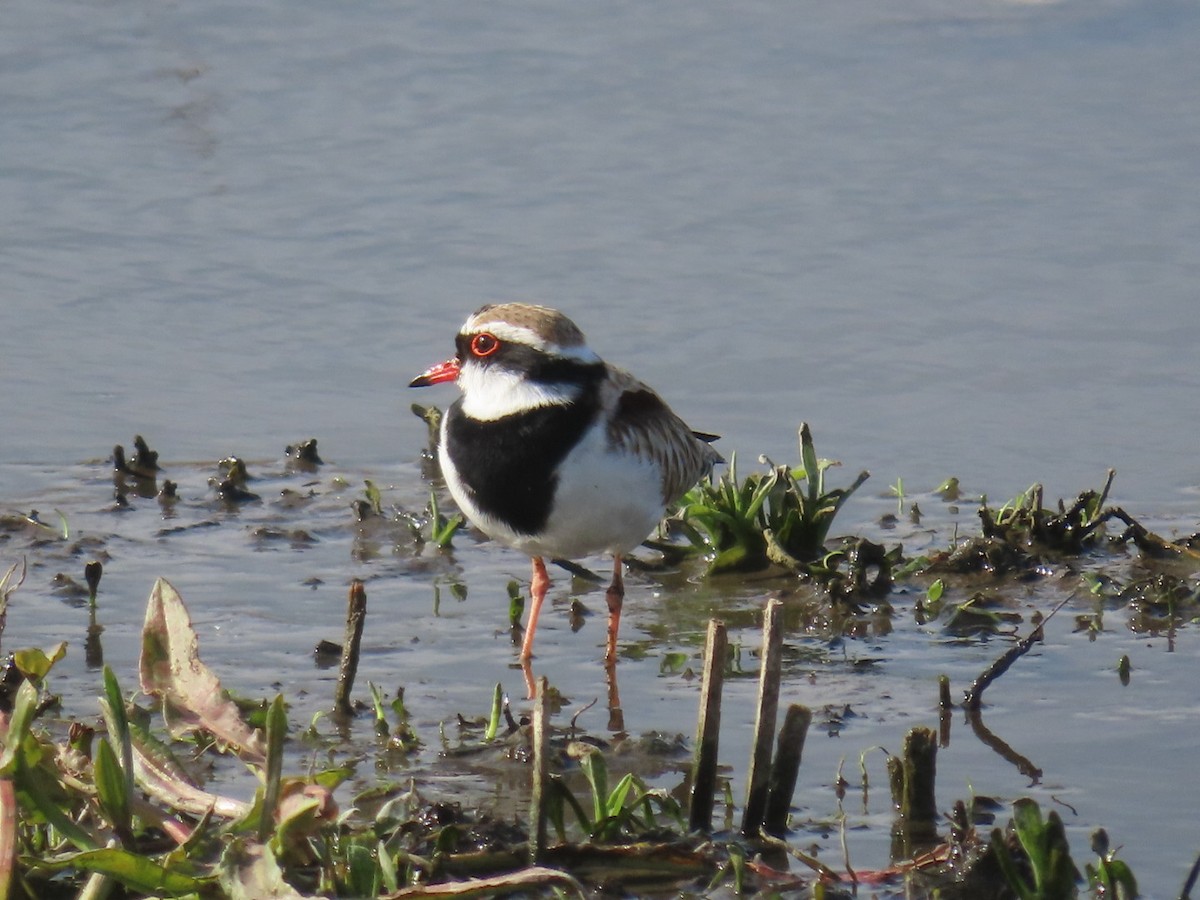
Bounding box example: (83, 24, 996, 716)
(140, 578, 266, 766)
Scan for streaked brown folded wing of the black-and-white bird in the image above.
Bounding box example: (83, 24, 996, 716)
(602, 368, 722, 504)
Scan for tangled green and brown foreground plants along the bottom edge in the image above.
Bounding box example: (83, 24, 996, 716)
(0, 571, 1156, 900)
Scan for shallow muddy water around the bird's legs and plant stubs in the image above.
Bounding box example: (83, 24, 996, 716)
(0, 448, 1200, 896)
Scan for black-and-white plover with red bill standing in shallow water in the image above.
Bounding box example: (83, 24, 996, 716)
(409, 302, 724, 666)
